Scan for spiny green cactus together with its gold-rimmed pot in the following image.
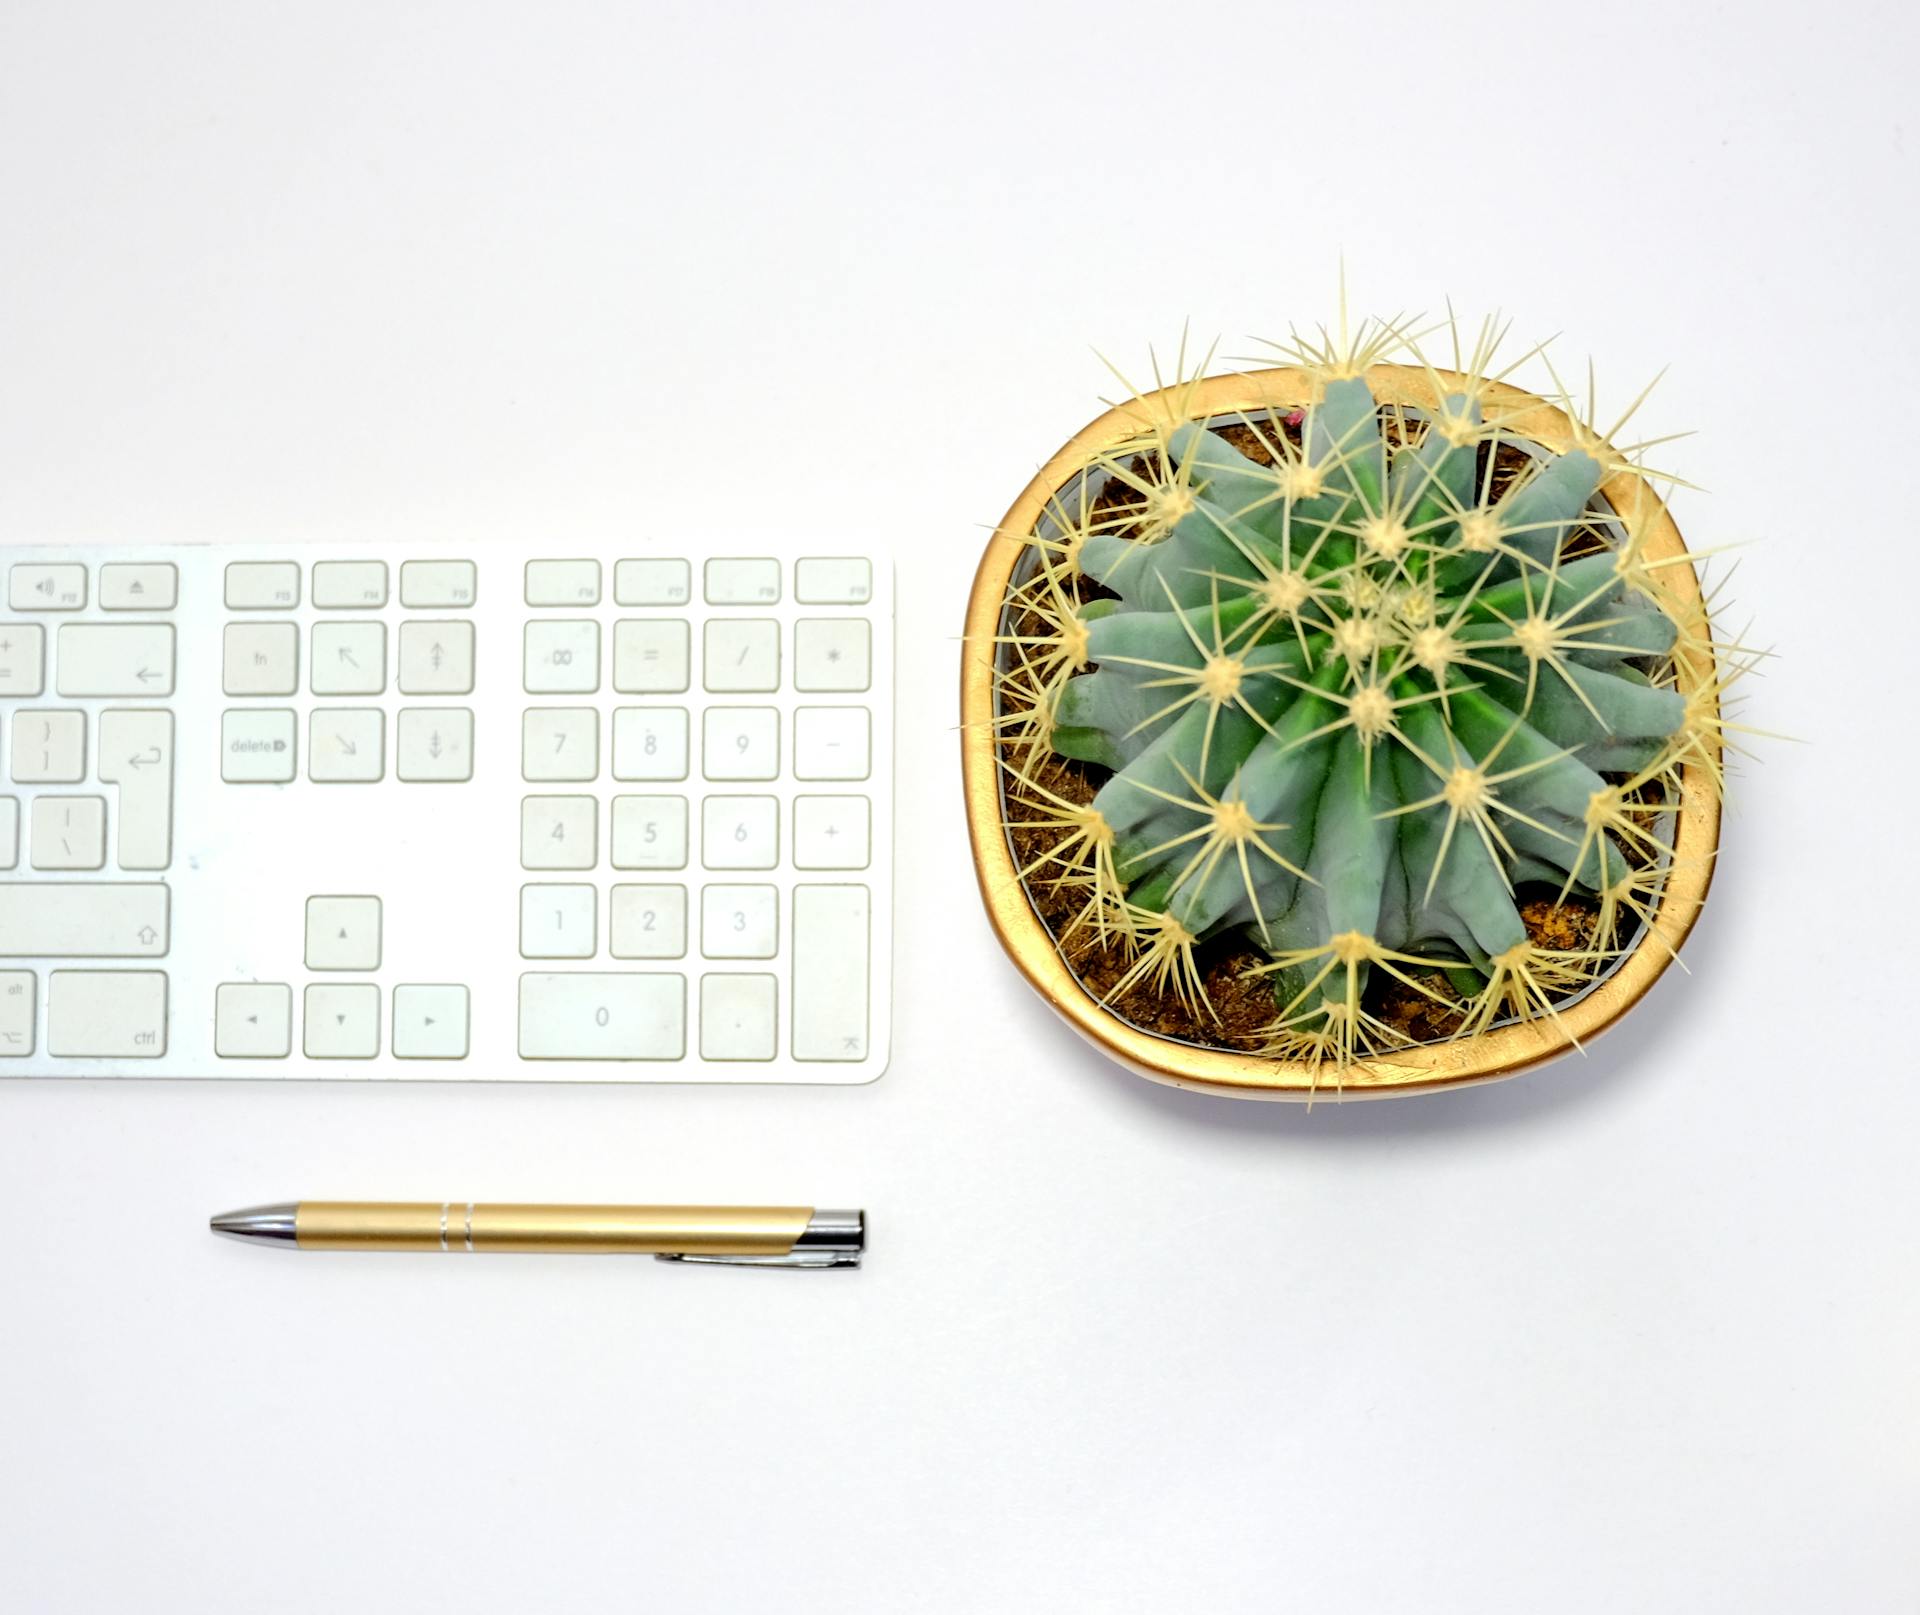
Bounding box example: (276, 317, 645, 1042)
(962, 311, 1745, 1098)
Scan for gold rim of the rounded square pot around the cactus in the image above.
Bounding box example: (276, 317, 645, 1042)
(960, 365, 1720, 1100)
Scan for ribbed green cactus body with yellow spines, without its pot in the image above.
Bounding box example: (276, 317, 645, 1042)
(1013, 349, 1688, 1058)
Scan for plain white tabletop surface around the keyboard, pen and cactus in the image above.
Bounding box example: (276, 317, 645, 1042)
(0, 0, 1920, 1615)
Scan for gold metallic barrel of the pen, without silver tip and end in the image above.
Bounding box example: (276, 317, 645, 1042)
(294, 1200, 814, 1256)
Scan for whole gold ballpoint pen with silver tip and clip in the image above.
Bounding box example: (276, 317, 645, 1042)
(211, 1200, 866, 1267)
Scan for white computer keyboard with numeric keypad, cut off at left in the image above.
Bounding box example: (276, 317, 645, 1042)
(0, 540, 893, 1083)
